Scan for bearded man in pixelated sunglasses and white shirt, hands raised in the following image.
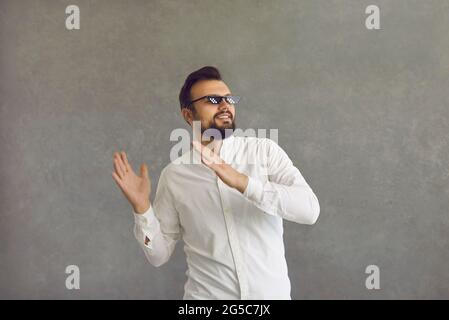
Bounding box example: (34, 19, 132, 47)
(112, 67, 320, 300)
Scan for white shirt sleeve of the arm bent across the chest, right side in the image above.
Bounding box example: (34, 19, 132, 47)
(243, 139, 320, 224)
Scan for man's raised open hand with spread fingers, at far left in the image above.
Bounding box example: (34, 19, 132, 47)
(112, 151, 151, 213)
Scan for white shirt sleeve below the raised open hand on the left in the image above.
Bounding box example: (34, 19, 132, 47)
(133, 169, 181, 267)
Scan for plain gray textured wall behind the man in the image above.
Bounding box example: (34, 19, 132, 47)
(0, 0, 449, 299)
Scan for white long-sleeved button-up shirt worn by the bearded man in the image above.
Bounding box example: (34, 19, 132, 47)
(133, 135, 320, 300)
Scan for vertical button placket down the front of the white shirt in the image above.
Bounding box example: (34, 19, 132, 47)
(217, 138, 248, 300)
